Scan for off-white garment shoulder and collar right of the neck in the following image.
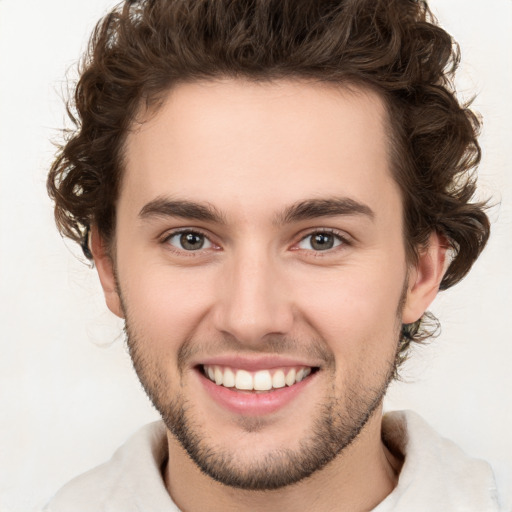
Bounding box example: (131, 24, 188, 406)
(375, 411, 499, 512)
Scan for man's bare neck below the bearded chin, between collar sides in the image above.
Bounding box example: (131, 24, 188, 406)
(165, 409, 400, 512)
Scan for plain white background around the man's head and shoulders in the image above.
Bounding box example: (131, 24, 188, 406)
(0, 0, 512, 512)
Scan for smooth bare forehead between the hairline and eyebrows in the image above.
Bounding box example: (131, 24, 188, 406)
(120, 80, 397, 222)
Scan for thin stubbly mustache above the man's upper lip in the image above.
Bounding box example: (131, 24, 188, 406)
(177, 333, 335, 373)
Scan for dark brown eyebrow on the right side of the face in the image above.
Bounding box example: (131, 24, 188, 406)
(275, 197, 375, 224)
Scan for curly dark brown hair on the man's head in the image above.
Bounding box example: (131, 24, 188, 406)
(47, 0, 490, 352)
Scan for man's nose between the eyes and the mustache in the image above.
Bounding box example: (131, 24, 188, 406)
(214, 247, 293, 346)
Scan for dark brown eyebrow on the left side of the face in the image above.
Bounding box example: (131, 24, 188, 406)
(139, 197, 226, 224)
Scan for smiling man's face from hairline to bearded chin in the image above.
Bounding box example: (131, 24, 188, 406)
(97, 80, 438, 489)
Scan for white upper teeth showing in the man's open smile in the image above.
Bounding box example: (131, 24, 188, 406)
(203, 365, 311, 391)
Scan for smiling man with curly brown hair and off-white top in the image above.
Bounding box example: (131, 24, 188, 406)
(47, 0, 498, 512)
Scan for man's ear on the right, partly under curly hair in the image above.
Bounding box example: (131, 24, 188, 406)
(402, 233, 447, 324)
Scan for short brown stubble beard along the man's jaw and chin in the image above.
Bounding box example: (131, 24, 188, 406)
(125, 317, 399, 490)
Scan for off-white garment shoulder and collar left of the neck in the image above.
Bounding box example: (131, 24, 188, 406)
(44, 421, 178, 512)
